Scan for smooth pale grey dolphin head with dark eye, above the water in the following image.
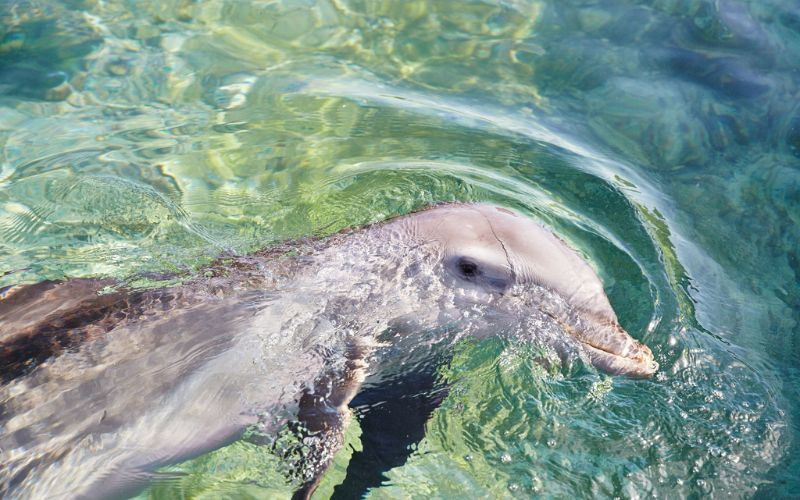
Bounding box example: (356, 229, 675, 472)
(390, 204, 658, 377)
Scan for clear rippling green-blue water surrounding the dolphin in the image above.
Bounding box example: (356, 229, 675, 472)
(0, 0, 800, 498)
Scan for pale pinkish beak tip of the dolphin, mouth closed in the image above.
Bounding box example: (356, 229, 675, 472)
(575, 322, 658, 378)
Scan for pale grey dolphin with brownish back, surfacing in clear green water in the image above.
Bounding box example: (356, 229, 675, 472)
(0, 204, 658, 498)
